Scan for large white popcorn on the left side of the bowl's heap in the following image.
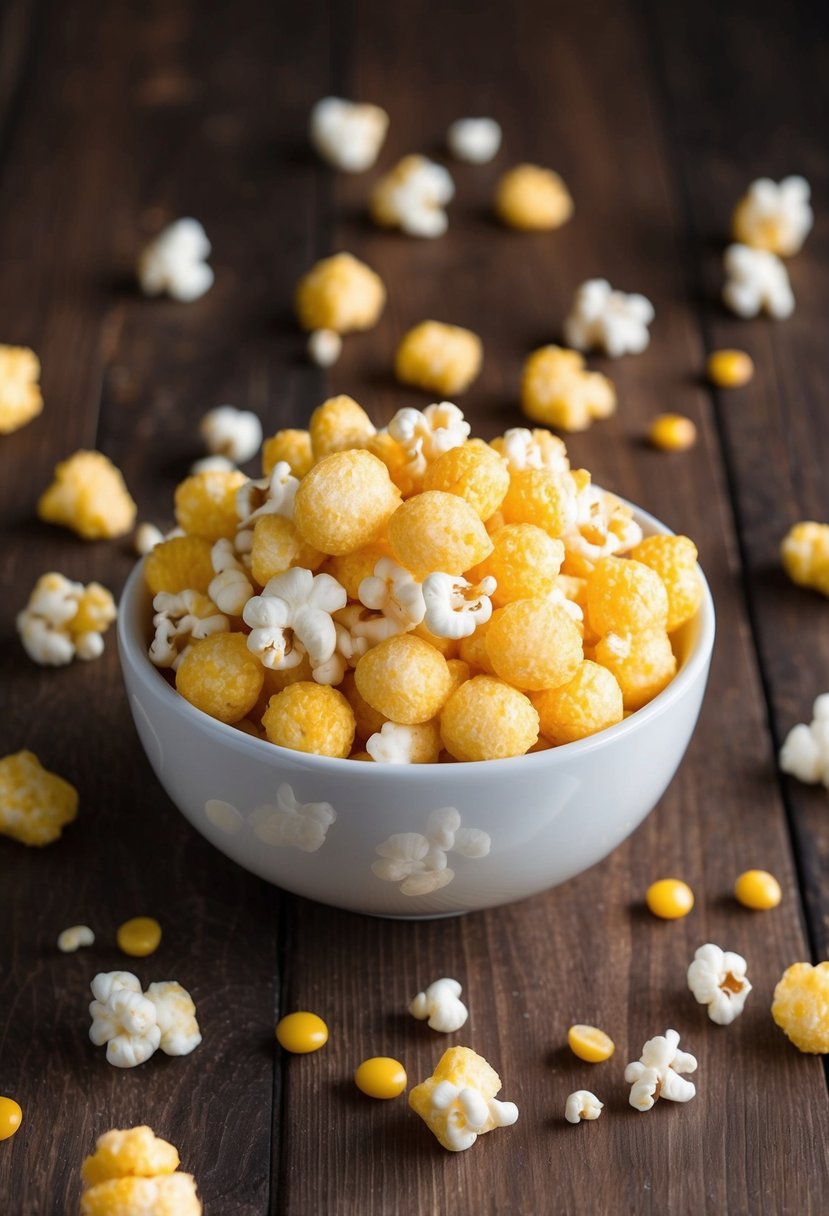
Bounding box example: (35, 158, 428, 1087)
(242, 565, 348, 671)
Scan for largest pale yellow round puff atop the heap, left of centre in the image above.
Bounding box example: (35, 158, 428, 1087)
(294, 450, 400, 557)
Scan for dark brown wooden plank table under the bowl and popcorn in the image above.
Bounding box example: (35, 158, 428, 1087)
(0, 0, 829, 1216)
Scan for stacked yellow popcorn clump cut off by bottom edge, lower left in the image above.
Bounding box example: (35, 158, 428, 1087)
(80, 1126, 202, 1216)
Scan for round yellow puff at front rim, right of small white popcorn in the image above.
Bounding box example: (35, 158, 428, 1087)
(440, 675, 538, 760)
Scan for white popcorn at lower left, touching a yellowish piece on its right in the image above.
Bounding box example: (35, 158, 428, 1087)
(89, 972, 162, 1068)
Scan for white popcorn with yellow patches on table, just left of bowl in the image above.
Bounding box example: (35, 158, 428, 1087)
(16, 572, 118, 666)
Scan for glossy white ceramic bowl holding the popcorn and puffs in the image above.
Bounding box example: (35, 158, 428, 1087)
(118, 498, 715, 918)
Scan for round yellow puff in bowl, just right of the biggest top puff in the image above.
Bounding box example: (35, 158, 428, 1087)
(388, 490, 492, 579)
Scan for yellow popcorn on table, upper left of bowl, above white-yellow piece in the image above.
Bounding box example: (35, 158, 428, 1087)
(38, 451, 137, 540)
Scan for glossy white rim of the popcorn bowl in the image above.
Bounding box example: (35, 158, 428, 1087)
(117, 495, 716, 784)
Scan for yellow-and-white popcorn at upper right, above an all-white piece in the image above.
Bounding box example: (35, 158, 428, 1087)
(732, 176, 814, 258)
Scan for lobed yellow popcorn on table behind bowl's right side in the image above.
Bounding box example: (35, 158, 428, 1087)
(521, 347, 616, 432)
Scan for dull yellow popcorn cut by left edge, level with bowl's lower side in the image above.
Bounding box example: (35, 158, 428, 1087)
(0, 751, 78, 846)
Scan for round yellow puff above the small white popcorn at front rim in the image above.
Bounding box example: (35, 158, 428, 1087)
(354, 634, 452, 726)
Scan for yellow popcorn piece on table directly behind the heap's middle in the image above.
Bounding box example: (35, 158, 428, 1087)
(394, 321, 484, 398)
